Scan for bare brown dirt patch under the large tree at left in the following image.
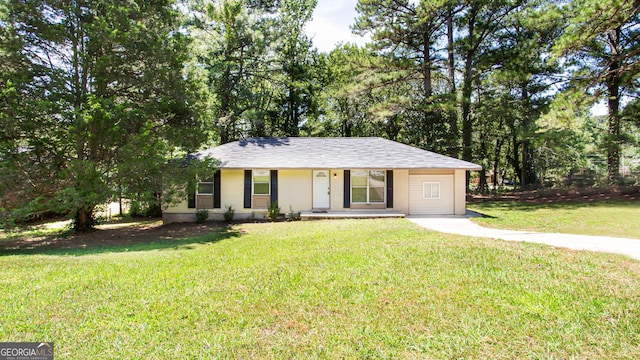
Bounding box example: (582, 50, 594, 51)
(0, 219, 238, 254)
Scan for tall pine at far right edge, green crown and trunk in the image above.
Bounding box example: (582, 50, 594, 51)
(554, 0, 640, 181)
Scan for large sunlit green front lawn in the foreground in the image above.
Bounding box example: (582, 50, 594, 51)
(0, 219, 640, 359)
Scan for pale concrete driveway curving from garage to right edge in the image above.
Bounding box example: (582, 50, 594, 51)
(407, 212, 640, 260)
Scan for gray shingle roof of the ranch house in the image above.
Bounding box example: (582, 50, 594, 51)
(194, 137, 482, 170)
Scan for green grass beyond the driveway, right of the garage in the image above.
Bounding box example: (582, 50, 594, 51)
(468, 201, 640, 239)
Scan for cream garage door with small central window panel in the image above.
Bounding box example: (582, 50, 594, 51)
(409, 175, 454, 215)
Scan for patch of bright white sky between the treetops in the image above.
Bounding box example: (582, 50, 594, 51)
(306, 0, 368, 53)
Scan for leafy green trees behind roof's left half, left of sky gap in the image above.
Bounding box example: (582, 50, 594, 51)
(189, 0, 322, 143)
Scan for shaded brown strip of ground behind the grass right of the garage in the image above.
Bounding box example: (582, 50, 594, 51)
(468, 186, 640, 204)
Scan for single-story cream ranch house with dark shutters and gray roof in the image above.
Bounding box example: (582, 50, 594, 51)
(163, 137, 481, 223)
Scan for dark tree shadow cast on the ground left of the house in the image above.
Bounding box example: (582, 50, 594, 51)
(0, 221, 242, 256)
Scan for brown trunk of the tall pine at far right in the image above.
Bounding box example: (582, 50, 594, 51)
(607, 27, 621, 181)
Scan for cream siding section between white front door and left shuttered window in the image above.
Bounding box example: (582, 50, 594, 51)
(278, 170, 313, 213)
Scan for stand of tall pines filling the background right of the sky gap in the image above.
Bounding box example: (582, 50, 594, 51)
(340, 0, 640, 187)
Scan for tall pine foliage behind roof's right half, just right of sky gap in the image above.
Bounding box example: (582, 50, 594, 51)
(354, 0, 458, 153)
